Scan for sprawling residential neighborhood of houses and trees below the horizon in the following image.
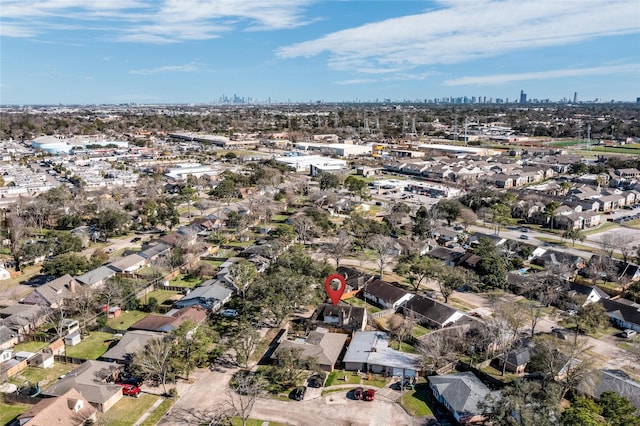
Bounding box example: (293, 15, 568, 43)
(0, 105, 640, 425)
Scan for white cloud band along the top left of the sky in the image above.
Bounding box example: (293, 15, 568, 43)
(0, 0, 312, 43)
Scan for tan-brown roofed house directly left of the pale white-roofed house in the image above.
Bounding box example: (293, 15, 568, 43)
(271, 331, 349, 372)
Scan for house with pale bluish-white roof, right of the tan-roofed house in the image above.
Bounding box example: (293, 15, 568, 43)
(342, 331, 420, 377)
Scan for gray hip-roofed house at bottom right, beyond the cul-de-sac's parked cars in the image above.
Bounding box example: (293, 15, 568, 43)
(427, 371, 497, 424)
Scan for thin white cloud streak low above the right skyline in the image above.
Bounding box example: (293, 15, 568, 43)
(443, 64, 640, 86)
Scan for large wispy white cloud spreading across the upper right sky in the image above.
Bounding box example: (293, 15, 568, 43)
(276, 0, 640, 73)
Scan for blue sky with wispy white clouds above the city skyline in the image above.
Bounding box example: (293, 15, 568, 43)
(0, 0, 640, 104)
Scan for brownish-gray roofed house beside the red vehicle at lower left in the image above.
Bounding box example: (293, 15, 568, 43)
(42, 360, 122, 412)
